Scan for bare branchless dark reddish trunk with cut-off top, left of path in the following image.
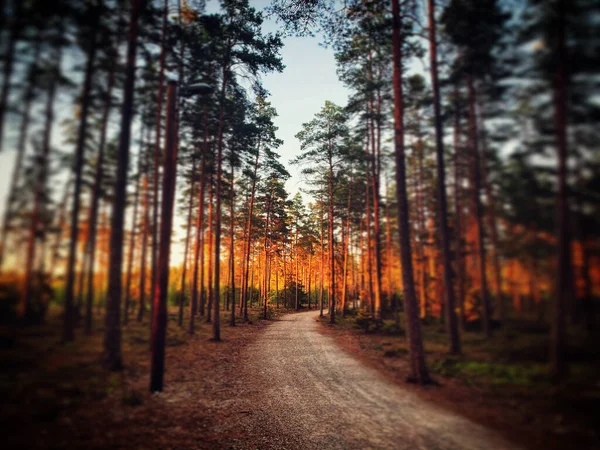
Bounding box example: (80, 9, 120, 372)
(150, 81, 177, 392)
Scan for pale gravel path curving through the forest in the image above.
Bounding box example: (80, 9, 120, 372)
(239, 311, 518, 450)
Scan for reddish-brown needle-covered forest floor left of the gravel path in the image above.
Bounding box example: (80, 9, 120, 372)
(0, 308, 280, 450)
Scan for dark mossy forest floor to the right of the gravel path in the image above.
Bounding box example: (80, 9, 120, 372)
(319, 316, 600, 450)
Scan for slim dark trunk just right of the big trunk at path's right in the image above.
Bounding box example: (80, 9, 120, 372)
(428, 0, 460, 353)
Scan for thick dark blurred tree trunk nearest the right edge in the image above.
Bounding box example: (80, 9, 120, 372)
(550, 0, 573, 379)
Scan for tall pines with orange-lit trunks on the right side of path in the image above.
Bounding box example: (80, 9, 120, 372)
(271, 0, 600, 382)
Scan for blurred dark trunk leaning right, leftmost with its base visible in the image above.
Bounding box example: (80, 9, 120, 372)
(17, 48, 62, 320)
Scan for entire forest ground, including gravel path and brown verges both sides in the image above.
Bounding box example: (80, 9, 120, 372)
(0, 308, 600, 450)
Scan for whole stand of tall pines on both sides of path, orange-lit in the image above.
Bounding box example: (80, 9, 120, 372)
(0, 0, 600, 390)
